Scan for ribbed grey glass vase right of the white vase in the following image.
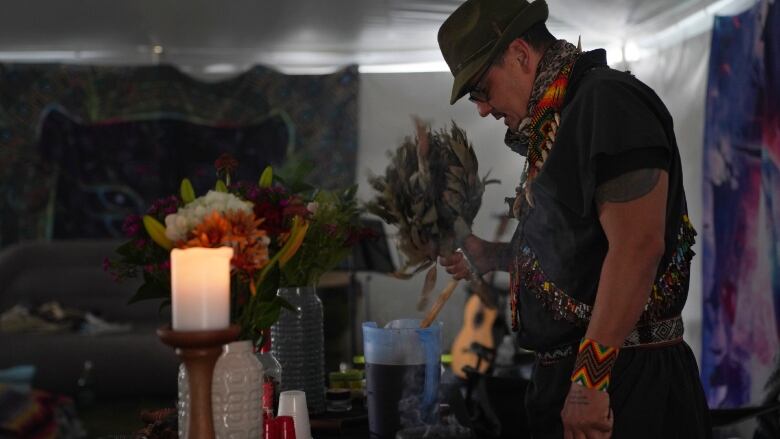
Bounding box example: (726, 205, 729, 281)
(271, 287, 325, 414)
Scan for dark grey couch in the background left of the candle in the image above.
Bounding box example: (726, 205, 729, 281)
(0, 240, 178, 399)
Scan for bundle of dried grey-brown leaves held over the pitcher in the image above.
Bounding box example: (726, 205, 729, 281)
(367, 120, 498, 326)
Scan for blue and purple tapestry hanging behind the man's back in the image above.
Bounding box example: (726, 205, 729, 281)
(701, 1, 780, 408)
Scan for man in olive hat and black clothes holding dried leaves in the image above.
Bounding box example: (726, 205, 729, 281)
(439, 0, 712, 439)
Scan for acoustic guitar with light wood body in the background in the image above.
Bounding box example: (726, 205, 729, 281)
(450, 215, 509, 379)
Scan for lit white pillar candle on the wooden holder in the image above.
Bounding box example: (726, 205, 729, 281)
(171, 247, 233, 331)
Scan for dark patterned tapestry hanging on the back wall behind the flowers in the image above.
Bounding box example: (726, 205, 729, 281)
(0, 64, 358, 247)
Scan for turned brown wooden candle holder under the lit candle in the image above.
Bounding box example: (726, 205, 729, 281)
(157, 325, 241, 439)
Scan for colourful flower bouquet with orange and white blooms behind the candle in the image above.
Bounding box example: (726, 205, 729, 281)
(104, 155, 367, 343)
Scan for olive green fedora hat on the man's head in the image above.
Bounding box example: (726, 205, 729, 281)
(439, 0, 548, 104)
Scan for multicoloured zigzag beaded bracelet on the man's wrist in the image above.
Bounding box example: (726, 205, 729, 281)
(571, 338, 619, 392)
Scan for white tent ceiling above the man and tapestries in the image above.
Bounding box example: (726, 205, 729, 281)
(0, 0, 751, 74)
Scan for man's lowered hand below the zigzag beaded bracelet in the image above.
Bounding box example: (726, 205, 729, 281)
(561, 383, 613, 439)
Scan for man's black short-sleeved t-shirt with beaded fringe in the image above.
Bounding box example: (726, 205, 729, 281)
(513, 50, 695, 349)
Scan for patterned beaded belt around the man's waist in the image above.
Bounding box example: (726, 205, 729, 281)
(536, 316, 684, 366)
